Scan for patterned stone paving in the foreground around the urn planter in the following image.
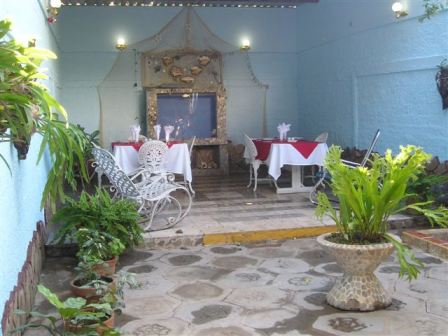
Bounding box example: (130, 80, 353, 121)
(32, 238, 448, 336)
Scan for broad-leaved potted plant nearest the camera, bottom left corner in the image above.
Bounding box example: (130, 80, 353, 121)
(12, 285, 121, 336)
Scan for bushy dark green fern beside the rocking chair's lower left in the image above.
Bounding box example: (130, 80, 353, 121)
(53, 188, 143, 248)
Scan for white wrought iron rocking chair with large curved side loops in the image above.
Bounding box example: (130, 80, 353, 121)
(92, 148, 192, 231)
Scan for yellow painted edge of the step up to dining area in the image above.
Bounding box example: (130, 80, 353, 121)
(203, 225, 336, 245)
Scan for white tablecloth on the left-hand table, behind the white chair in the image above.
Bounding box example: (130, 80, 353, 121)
(114, 143, 192, 182)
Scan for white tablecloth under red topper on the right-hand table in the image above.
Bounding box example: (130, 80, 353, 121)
(266, 143, 328, 180)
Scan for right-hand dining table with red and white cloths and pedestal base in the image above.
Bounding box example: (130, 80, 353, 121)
(244, 138, 328, 194)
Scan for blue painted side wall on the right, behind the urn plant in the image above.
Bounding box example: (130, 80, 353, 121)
(296, 0, 448, 159)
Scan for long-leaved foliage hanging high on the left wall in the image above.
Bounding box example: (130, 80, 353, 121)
(0, 20, 89, 207)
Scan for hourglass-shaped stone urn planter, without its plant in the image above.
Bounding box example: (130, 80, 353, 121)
(317, 233, 394, 311)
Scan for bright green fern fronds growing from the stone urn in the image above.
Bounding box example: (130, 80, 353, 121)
(316, 146, 448, 279)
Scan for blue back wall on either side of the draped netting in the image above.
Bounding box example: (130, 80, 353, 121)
(59, 6, 297, 142)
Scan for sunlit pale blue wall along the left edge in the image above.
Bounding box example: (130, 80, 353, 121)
(0, 0, 58, 326)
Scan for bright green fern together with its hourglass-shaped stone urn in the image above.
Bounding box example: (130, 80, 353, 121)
(316, 146, 448, 311)
